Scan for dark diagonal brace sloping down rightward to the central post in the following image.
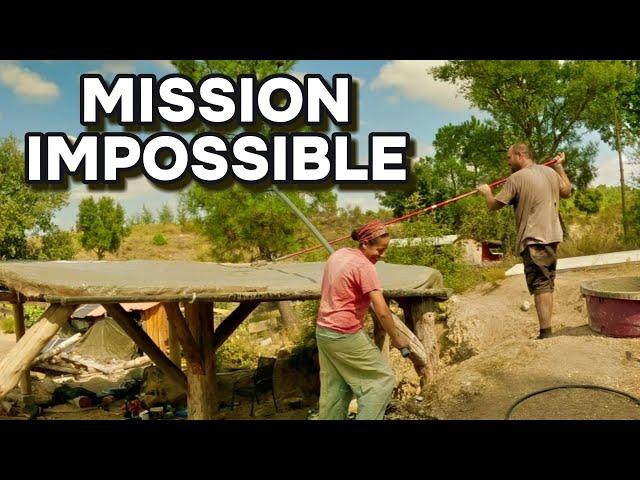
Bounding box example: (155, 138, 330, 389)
(102, 303, 187, 391)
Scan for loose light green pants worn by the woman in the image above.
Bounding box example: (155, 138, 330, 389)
(316, 327, 396, 420)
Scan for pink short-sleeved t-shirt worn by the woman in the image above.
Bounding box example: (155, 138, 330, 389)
(317, 248, 382, 333)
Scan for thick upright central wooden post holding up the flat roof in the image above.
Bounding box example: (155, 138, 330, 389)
(184, 302, 218, 420)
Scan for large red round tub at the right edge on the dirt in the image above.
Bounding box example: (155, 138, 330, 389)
(580, 277, 640, 337)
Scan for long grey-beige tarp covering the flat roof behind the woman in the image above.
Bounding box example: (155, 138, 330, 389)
(0, 260, 451, 303)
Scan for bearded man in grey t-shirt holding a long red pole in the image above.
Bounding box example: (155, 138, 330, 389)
(478, 143, 571, 339)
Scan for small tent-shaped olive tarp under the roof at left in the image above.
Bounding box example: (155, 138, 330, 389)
(71, 317, 138, 362)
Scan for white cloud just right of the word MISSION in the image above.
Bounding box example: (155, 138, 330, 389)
(371, 60, 471, 111)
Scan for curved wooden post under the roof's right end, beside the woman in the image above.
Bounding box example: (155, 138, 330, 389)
(403, 298, 440, 387)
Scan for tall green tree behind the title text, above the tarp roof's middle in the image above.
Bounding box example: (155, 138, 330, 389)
(172, 60, 336, 261)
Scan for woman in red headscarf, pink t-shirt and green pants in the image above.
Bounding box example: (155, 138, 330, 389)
(316, 220, 408, 420)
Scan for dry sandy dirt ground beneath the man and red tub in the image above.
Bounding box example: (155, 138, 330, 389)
(394, 263, 640, 419)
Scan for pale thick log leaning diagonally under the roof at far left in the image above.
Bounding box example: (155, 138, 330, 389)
(0, 304, 78, 400)
